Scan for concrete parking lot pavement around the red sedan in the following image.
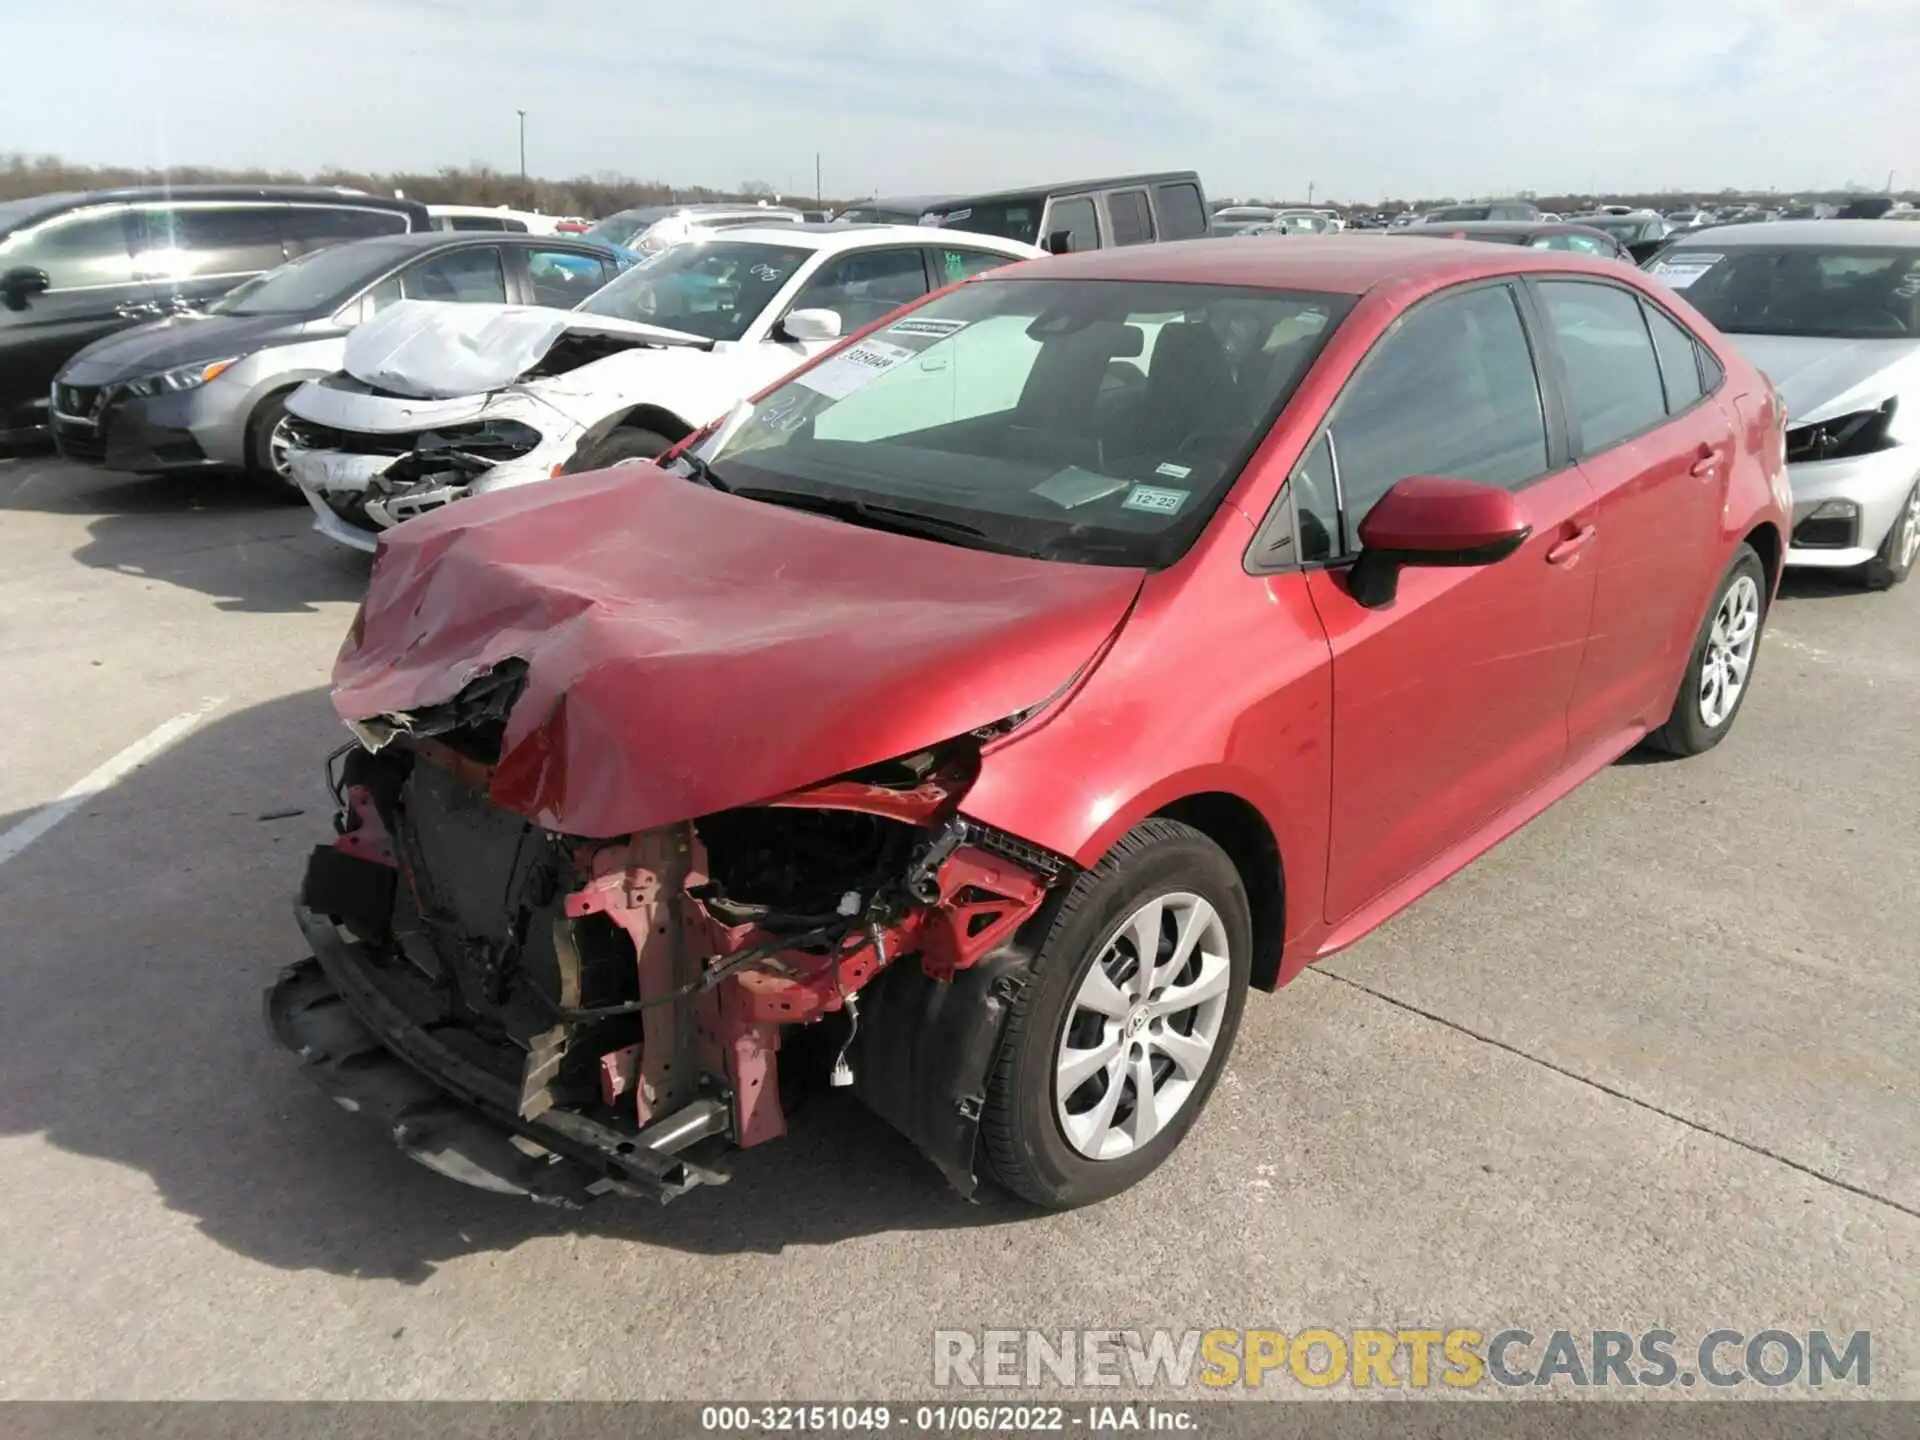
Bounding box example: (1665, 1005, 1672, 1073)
(0, 455, 1920, 1398)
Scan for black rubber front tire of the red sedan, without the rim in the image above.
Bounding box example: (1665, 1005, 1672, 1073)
(981, 820, 1252, 1210)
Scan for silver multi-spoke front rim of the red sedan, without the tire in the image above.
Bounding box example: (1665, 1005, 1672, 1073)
(1054, 891, 1233, 1160)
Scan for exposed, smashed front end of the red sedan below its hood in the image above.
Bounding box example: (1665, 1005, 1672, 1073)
(267, 683, 1069, 1204)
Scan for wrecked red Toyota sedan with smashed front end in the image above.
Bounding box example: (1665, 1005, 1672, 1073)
(278, 236, 1789, 1206)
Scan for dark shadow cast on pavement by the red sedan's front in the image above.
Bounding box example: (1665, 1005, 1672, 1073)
(0, 689, 1031, 1283)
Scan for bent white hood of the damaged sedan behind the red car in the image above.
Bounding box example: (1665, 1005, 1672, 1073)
(344, 300, 712, 399)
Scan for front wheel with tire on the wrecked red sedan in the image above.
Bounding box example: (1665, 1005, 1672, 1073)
(981, 820, 1252, 1210)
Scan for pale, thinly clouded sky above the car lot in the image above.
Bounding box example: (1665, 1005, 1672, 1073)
(0, 0, 1920, 202)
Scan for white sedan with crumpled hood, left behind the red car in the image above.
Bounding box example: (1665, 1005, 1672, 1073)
(286, 225, 1043, 551)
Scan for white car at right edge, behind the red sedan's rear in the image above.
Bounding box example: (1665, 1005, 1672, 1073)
(1647, 221, 1920, 589)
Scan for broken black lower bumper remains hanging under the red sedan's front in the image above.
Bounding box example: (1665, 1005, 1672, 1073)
(267, 908, 730, 1208)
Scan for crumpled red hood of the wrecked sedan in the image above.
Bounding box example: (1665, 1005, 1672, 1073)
(334, 467, 1142, 839)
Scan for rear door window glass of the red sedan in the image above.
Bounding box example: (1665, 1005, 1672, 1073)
(1540, 280, 1667, 455)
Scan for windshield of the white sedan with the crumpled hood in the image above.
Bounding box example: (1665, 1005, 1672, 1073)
(574, 240, 814, 340)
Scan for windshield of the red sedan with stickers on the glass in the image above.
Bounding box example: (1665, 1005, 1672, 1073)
(707, 280, 1354, 566)
